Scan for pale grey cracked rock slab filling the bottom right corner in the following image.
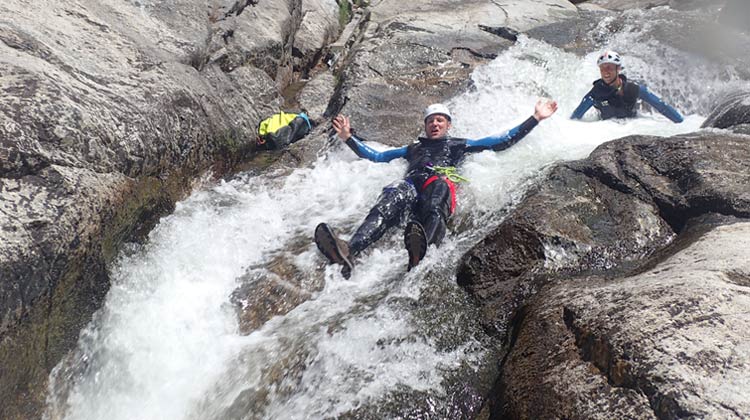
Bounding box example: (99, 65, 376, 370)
(501, 216, 750, 419)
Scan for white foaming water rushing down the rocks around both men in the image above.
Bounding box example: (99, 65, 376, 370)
(45, 14, 736, 420)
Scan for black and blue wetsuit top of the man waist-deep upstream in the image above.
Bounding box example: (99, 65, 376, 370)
(571, 74, 683, 123)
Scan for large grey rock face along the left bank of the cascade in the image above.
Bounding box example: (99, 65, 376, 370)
(0, 0, 338, 418)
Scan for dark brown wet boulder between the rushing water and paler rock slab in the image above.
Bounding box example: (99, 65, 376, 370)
(458, 133, 750, 335)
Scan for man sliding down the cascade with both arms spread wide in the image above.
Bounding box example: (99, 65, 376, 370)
(315, 100, 557, 278)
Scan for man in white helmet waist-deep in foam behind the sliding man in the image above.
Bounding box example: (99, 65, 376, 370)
(571, 51, 683, 123)
